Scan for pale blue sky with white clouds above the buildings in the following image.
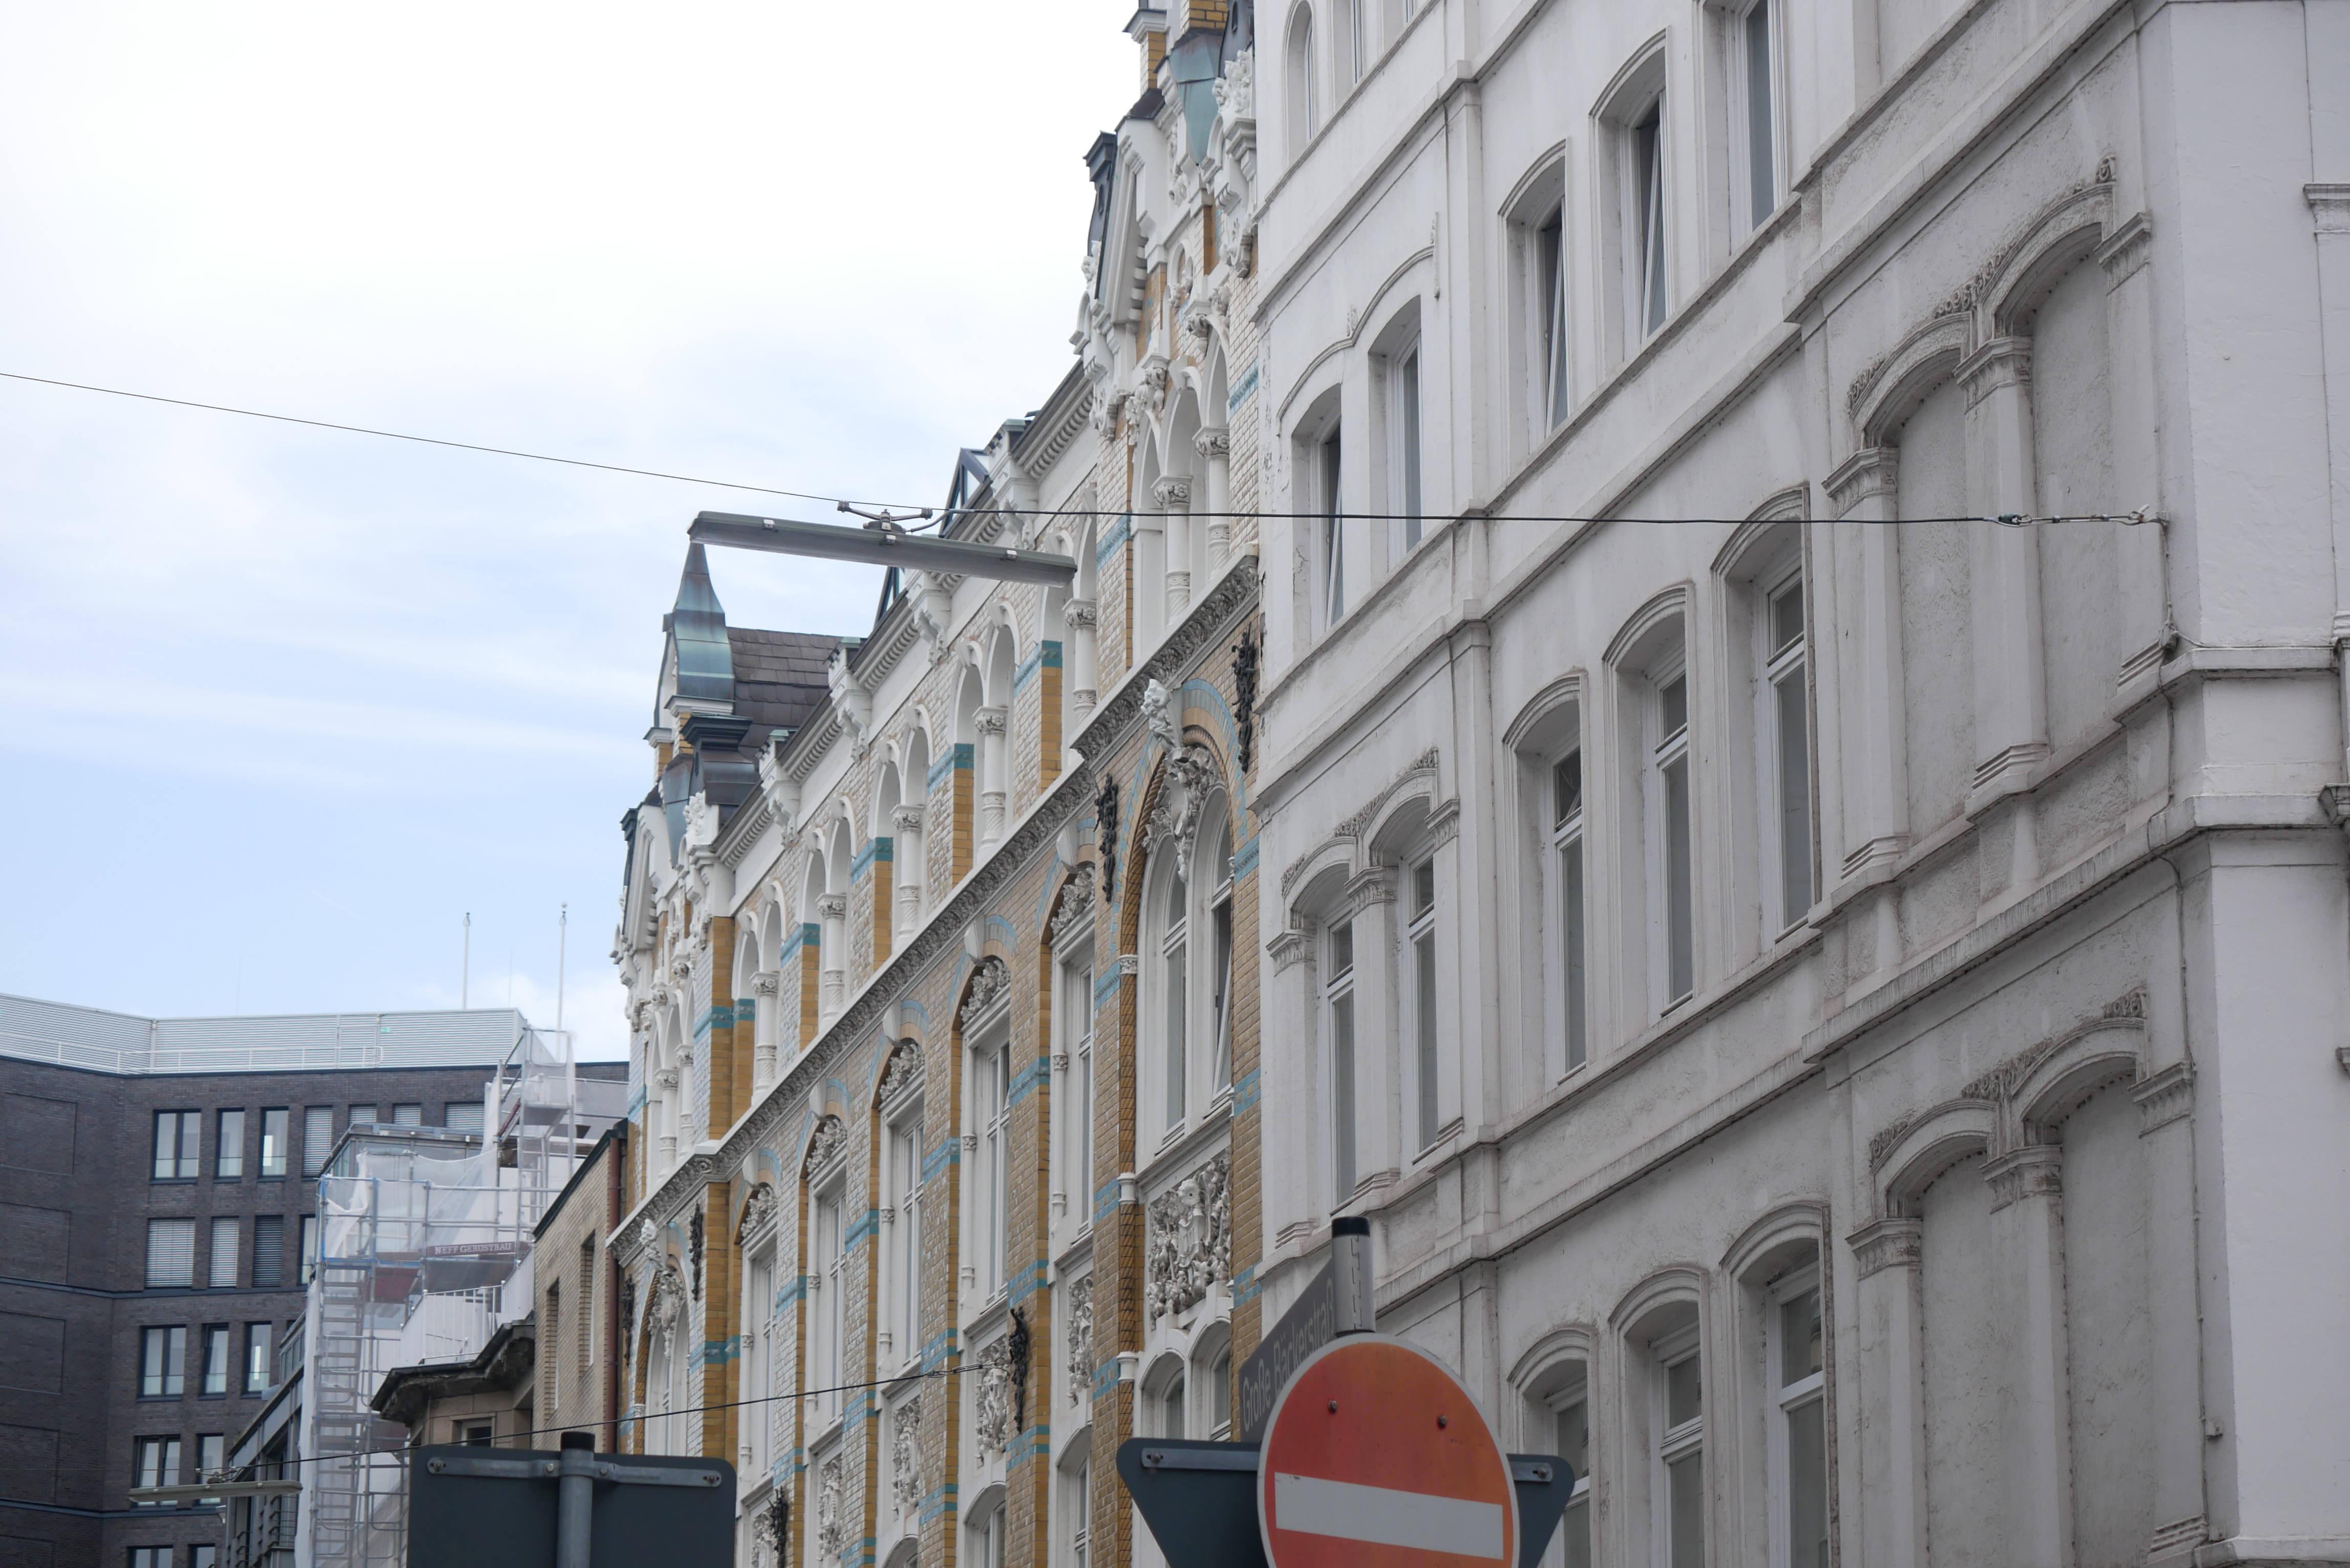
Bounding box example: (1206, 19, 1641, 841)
(0, 0, 1138, 1058)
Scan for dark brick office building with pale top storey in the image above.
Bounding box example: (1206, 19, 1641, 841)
(0, 997, 545, 1568)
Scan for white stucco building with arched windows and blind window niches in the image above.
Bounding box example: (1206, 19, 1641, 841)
(1250, 0, 2350, 1568)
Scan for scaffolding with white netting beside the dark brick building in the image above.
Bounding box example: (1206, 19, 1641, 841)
(301, 1025, 618, 1568)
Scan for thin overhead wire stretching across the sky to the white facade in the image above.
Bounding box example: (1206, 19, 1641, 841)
(0, 372, 2162, 534)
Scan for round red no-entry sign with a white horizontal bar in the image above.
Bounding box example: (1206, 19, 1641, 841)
(1257, 1333, 1518, 1568)
